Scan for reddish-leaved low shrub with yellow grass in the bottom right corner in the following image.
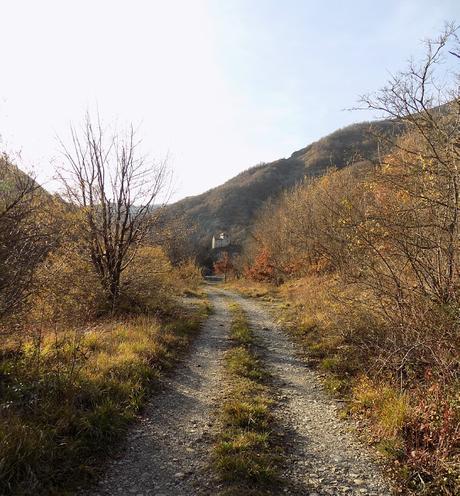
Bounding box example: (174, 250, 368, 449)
(350, 375, 460, 495)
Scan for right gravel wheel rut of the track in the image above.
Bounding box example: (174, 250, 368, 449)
(222, 291, 392, 496)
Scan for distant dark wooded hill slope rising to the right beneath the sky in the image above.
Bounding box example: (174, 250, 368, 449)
(166, 121, 394, 254)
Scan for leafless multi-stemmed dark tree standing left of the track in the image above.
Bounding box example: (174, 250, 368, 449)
(59, 114, 169, 311)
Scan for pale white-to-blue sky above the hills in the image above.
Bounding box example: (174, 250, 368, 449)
(0, 0, 460, 200)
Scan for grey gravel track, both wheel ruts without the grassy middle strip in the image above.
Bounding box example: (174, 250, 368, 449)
(81, 286, 392, 496)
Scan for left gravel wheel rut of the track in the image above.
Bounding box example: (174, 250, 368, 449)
(81, 291, 230, 496)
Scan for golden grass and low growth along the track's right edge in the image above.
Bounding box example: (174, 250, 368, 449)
(270, 275, 460, 496)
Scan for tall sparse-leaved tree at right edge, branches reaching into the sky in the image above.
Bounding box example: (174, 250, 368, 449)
(362, 24, 460, 303)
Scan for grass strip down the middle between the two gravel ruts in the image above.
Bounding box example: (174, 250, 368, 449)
(214, 305, 281, 496)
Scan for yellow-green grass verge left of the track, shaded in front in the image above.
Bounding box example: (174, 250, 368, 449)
(0, 303, 207, 496)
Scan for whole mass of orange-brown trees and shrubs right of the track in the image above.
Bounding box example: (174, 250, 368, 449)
(246, 25, 460, 494)
